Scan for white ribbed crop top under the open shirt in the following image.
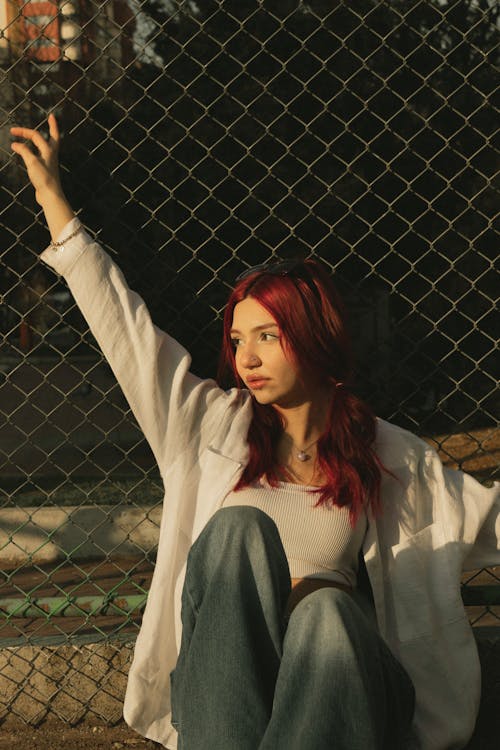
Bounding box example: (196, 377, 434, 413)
(223, 479, 367, 588)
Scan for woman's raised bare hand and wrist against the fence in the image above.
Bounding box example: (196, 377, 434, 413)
(10, 114, 75, 240)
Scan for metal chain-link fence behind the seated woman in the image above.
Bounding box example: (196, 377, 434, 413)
(0, 0, 500, 723)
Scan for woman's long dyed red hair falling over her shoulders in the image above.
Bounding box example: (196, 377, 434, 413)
(219, 260, 382, 525)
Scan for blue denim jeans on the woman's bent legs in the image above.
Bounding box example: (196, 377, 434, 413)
(171, 506, 414, 750)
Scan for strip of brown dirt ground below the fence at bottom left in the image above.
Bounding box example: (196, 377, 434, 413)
(0, 721, 162, 750)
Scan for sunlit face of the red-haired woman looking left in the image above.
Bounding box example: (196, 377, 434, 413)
(231, 297, 309, 408)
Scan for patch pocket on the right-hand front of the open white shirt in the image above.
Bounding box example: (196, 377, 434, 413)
(390, 523, 465, 641)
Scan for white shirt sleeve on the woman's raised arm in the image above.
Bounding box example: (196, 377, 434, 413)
(41, 219, 232, 469)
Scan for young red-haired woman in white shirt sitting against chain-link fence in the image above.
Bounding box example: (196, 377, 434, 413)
(12, 116, 500, 750)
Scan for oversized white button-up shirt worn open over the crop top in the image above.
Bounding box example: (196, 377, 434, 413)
(42, 219, 500, 750)
